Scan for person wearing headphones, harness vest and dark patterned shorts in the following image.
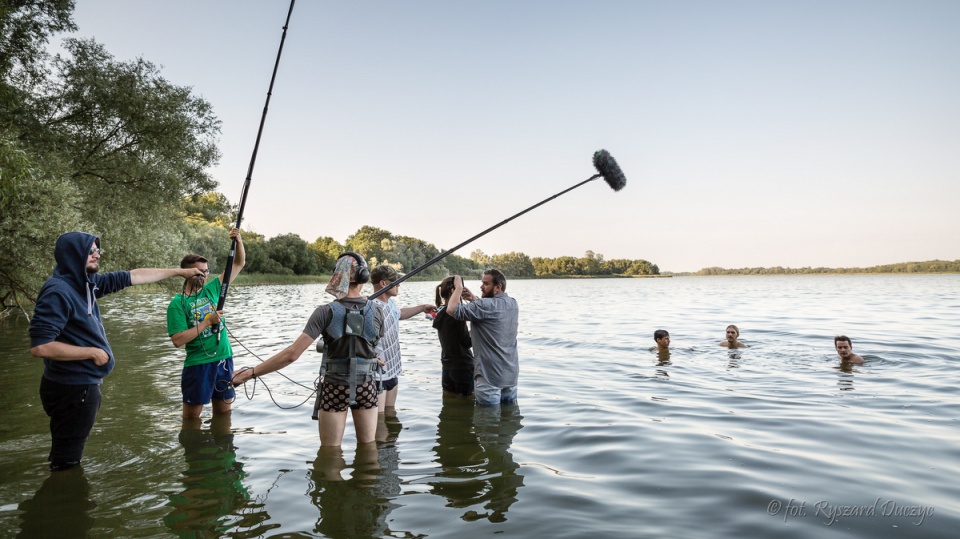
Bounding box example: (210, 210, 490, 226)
(233, 253, 383, 447)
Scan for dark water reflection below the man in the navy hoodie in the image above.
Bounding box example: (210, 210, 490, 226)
(17, 465, 97, 539)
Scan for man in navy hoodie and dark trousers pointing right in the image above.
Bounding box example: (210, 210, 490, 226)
(30, 232, 200, 471)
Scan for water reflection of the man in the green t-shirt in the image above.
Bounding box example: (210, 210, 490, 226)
(163, 414, 250, 537)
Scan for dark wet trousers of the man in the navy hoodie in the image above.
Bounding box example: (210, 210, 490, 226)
(40, 378, 100, 470)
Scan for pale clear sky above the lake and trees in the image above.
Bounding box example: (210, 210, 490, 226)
(65, 0, 960, 271)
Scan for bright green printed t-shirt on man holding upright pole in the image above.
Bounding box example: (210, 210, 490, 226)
(167, 276, 233, 367)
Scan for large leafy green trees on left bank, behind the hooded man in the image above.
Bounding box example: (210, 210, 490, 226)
(0, 11, 219, 308)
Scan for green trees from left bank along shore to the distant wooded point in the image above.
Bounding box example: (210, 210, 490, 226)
(0, 0, 658, 318)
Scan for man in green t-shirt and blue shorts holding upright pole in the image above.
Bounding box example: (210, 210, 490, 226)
(167, 228, 246, 419)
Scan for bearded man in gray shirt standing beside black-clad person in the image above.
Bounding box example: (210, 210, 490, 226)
(447, 269, 520, 406)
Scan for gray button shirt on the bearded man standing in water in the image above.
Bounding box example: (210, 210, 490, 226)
(453, 292, 520, 388)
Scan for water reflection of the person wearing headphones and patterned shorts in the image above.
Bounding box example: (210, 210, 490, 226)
(310, 442, 399, 538)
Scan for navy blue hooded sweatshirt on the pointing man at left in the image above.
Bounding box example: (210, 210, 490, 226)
(30, 232, 131, 385)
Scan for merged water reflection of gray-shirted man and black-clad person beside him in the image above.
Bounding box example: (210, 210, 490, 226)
(430, 395, 523, 522)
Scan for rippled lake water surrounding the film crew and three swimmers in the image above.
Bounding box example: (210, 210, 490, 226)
(0, 275, 960, 538)
